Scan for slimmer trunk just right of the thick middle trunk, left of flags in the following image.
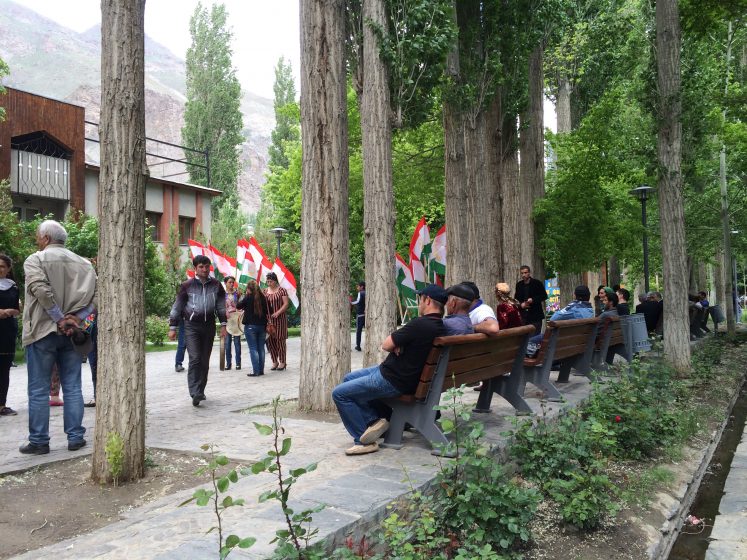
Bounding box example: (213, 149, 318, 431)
(361, 0, 396, 367)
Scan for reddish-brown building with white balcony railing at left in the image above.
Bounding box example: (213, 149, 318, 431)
(0, 88, 221, 245)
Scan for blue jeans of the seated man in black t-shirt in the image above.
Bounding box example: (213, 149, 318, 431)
(332, 366, 401, 445)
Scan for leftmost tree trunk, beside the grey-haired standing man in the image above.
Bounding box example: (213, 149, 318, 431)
(91, 0, 147, 482)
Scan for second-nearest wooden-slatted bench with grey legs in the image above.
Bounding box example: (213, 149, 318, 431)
(521, 318, 598, 402)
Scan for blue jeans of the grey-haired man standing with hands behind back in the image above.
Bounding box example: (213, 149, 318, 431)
(26, 333, 86, 445)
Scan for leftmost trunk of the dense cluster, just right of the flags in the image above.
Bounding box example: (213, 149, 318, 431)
(443, 5, 470, 286)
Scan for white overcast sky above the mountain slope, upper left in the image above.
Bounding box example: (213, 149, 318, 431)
(15, 0, 300, 99)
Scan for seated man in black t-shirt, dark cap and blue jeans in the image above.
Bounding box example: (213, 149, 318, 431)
(332, 284, 448, 455)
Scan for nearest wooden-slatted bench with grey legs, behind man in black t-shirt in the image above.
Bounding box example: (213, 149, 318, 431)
(382, 325, 534, 449)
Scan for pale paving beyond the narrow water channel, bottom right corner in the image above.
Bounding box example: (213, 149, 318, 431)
(705, 412, 747, 560)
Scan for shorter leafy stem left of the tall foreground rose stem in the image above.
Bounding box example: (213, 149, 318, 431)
(179, 443, 257, 560)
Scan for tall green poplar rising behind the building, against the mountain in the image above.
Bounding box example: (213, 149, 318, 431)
(182, 3, 244, 205)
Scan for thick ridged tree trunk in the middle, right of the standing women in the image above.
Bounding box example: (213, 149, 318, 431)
(298, 0, 352, 411)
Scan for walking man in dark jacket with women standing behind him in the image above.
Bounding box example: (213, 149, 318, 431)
(169, 255, 289, 406)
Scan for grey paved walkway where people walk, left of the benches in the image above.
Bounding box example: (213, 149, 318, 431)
(0, 336, 589, 560)
